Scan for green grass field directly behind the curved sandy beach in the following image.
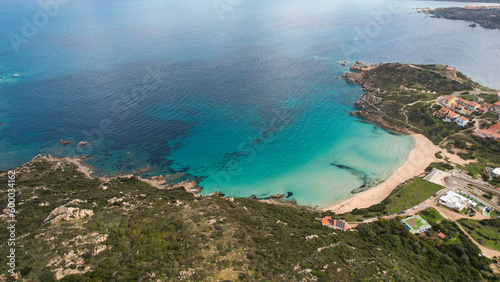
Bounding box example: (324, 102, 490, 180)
(387, 178, 442, 213)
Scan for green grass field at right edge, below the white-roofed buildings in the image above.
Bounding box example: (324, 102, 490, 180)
(458, 218, 500, 251)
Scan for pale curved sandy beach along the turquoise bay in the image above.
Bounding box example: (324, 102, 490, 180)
(324, 134, 441, 214)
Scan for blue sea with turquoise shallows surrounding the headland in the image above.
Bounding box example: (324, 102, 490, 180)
(0, 0, 500, 206)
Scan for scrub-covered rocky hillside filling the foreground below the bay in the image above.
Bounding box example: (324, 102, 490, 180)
(0, 158, 498, 281)
